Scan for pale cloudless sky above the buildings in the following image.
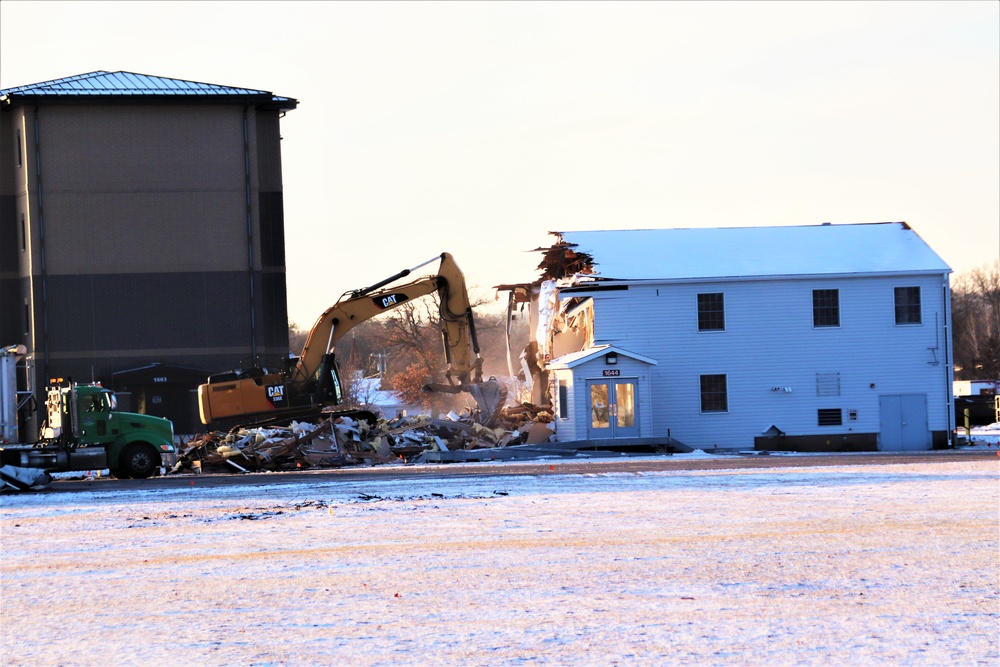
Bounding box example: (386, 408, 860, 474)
(0, 0, 1000, 326)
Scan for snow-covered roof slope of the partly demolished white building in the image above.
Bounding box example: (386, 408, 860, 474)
(553, 222, 951, 280)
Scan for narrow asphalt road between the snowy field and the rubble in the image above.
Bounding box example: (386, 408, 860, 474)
(39, 450, 998, 493)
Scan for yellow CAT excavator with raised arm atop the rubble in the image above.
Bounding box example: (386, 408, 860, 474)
(198, 253, 506, 425)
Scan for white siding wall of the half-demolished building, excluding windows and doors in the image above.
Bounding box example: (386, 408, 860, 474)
(577, 274, 951, 447)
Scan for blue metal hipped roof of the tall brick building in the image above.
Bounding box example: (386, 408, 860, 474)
(0, 70, 298, 109)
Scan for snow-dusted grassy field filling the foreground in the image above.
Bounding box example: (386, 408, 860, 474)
(0, 459, 1000, 667)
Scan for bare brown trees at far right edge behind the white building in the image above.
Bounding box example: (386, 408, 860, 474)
(951, 260, 1000, 380)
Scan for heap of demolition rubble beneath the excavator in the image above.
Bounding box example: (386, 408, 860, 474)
(170, 403, 553, 473)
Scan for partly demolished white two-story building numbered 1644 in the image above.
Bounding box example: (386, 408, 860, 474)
(534, 222, 954, 451)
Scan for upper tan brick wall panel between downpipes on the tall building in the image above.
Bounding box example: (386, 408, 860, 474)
(39, 105, 253, 274)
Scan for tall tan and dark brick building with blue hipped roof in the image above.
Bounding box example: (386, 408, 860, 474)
(0, 71, 298, 438)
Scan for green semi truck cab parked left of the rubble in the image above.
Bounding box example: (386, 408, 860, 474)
(0, 379, 177, 479)
